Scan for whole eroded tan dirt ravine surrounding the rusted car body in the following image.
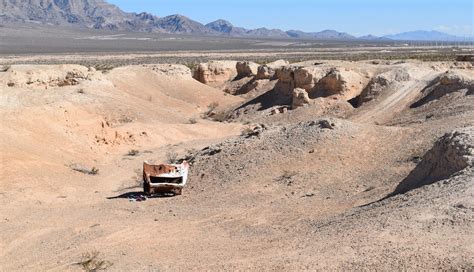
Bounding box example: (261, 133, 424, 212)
(0, 59, 474, 271)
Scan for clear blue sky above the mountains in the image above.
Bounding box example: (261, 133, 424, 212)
(108, 0, 474, 36)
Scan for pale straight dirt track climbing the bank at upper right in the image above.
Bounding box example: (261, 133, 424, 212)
(351, 71, 439, 123)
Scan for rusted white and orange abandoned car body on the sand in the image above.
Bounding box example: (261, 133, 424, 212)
(143, 161, 189, 195)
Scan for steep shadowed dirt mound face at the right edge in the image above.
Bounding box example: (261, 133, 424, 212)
(394, 127, 474, 194)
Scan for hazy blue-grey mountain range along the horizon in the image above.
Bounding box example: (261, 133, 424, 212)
(0, 0, 472, 41)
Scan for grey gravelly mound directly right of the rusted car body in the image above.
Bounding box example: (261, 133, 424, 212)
(188, 119, 356, 185)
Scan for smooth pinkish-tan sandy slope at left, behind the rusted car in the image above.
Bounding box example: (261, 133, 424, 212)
(0, 66, 240, 198)
